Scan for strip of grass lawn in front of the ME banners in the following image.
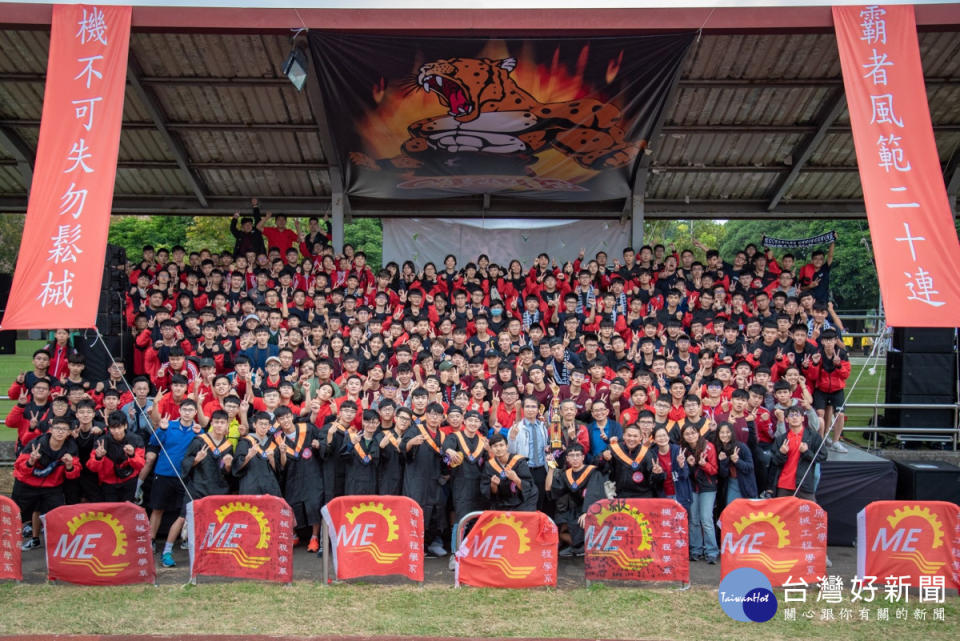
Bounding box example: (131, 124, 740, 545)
(0, 580, 960, 641)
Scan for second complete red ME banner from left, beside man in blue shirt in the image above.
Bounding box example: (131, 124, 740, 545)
(187, 494, 294, 583)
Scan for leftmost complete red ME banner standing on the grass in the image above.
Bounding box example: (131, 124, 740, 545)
(42, 503, 157, 585)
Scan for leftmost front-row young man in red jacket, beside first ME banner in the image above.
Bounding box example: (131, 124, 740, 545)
(12, 418, 83, 550)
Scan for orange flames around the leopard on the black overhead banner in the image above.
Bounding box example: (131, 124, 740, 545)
(356, 40, 623, 184)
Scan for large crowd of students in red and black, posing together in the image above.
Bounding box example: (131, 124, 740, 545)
(6, 201, 850, 567)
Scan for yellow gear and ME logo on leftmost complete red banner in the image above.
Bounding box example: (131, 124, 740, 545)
(53, 511, 130, 578)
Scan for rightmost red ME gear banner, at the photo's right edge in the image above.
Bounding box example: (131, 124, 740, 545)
(857, 501, 960, 590)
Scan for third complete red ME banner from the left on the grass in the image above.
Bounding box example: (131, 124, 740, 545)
(323, 496, 423, 581)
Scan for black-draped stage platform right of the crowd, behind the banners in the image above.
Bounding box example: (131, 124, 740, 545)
(817, 443, 897, 545)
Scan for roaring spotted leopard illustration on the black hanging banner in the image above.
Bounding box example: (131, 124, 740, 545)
(350, 58, 643, 173)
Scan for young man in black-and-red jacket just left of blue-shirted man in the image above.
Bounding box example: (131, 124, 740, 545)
(87, 412, 144, 502)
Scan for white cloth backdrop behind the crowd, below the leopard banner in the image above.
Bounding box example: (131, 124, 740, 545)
(383, 218, 630, 270)
